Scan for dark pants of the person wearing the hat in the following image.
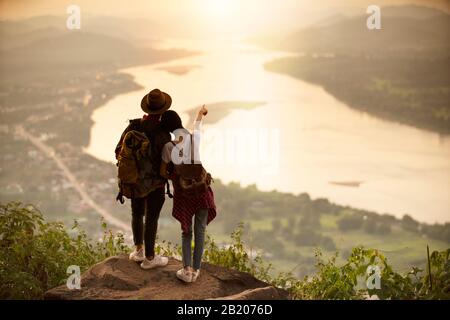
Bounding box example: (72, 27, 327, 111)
(131, 188, 165, 258)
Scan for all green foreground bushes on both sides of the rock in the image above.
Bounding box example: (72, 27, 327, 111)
(0, 202, 450, 299)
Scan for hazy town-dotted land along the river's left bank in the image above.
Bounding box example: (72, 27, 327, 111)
(0, 17, 194, 240)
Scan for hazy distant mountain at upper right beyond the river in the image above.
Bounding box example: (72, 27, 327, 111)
(255, 6, 450, 55)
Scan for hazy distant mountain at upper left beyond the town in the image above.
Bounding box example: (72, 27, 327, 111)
(0, 28, 193, 72)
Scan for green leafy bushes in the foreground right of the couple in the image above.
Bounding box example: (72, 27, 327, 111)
(205, 224, 450, 299)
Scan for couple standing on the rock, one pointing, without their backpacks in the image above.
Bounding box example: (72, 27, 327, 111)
(115, 89, 216, 282)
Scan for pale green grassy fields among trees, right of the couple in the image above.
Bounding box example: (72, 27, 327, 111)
(208, 209, 450, 272)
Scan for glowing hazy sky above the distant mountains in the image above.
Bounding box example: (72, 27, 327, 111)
(0, 0, 450, 33)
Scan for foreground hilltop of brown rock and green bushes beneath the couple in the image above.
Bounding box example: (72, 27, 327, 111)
(0, 203, 450, 300)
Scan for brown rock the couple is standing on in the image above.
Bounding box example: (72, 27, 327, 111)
(45, 254, 289, 300)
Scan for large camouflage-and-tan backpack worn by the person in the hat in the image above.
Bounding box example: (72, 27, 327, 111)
(117, 130, 156, 203)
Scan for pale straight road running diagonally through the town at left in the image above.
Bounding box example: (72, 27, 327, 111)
(15, 125, 131, 232)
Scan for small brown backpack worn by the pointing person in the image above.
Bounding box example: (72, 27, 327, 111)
(172, 135, 213, 198)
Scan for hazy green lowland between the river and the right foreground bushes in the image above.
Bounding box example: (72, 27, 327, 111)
(177, 180, 450, 278)
